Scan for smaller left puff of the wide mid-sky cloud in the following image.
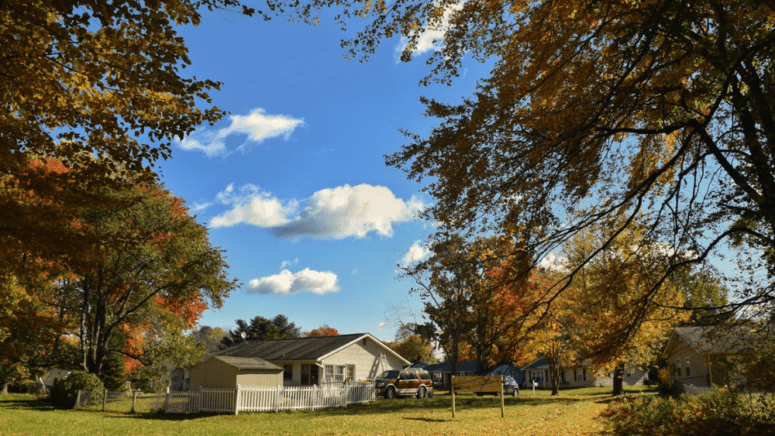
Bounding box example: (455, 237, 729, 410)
(210, 183, 298, 227)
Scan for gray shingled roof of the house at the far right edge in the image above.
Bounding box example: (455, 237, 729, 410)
(675, 326, 767, 354)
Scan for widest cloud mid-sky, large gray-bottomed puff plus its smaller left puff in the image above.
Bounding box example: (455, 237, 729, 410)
(211, 184, 424, 239)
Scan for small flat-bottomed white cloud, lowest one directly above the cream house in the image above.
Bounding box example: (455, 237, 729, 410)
(248, 268, 339, 295)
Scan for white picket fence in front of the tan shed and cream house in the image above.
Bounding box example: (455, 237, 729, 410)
(164, 384, 376, 414)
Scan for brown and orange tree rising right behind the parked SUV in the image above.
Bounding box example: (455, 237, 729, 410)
(405, 234, 530, 373)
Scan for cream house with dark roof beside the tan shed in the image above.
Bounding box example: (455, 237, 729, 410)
(211, 333, 410, 386)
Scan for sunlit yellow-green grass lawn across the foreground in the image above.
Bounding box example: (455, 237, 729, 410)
(0, 388, 656, 436)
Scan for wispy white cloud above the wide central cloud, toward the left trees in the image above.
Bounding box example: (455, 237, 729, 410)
(178, 108, 304, 156)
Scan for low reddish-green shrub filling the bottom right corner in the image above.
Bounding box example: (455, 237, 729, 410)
(601, 389, 775, 436)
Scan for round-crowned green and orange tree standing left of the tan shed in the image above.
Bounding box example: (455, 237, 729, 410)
(27, 185, 236, 375)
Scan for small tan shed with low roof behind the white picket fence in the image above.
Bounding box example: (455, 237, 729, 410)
(190, 356, 283, 390)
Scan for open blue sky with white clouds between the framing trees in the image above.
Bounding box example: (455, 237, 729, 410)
(160, 7, 484, 340)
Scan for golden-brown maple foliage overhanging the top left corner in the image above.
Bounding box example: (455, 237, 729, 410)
(0, 0, 252, 276)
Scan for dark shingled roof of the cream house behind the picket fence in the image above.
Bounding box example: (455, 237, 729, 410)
(216, 333, 378, 361)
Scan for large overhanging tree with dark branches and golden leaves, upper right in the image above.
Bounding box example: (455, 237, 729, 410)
(266, 0, 775, 340)
